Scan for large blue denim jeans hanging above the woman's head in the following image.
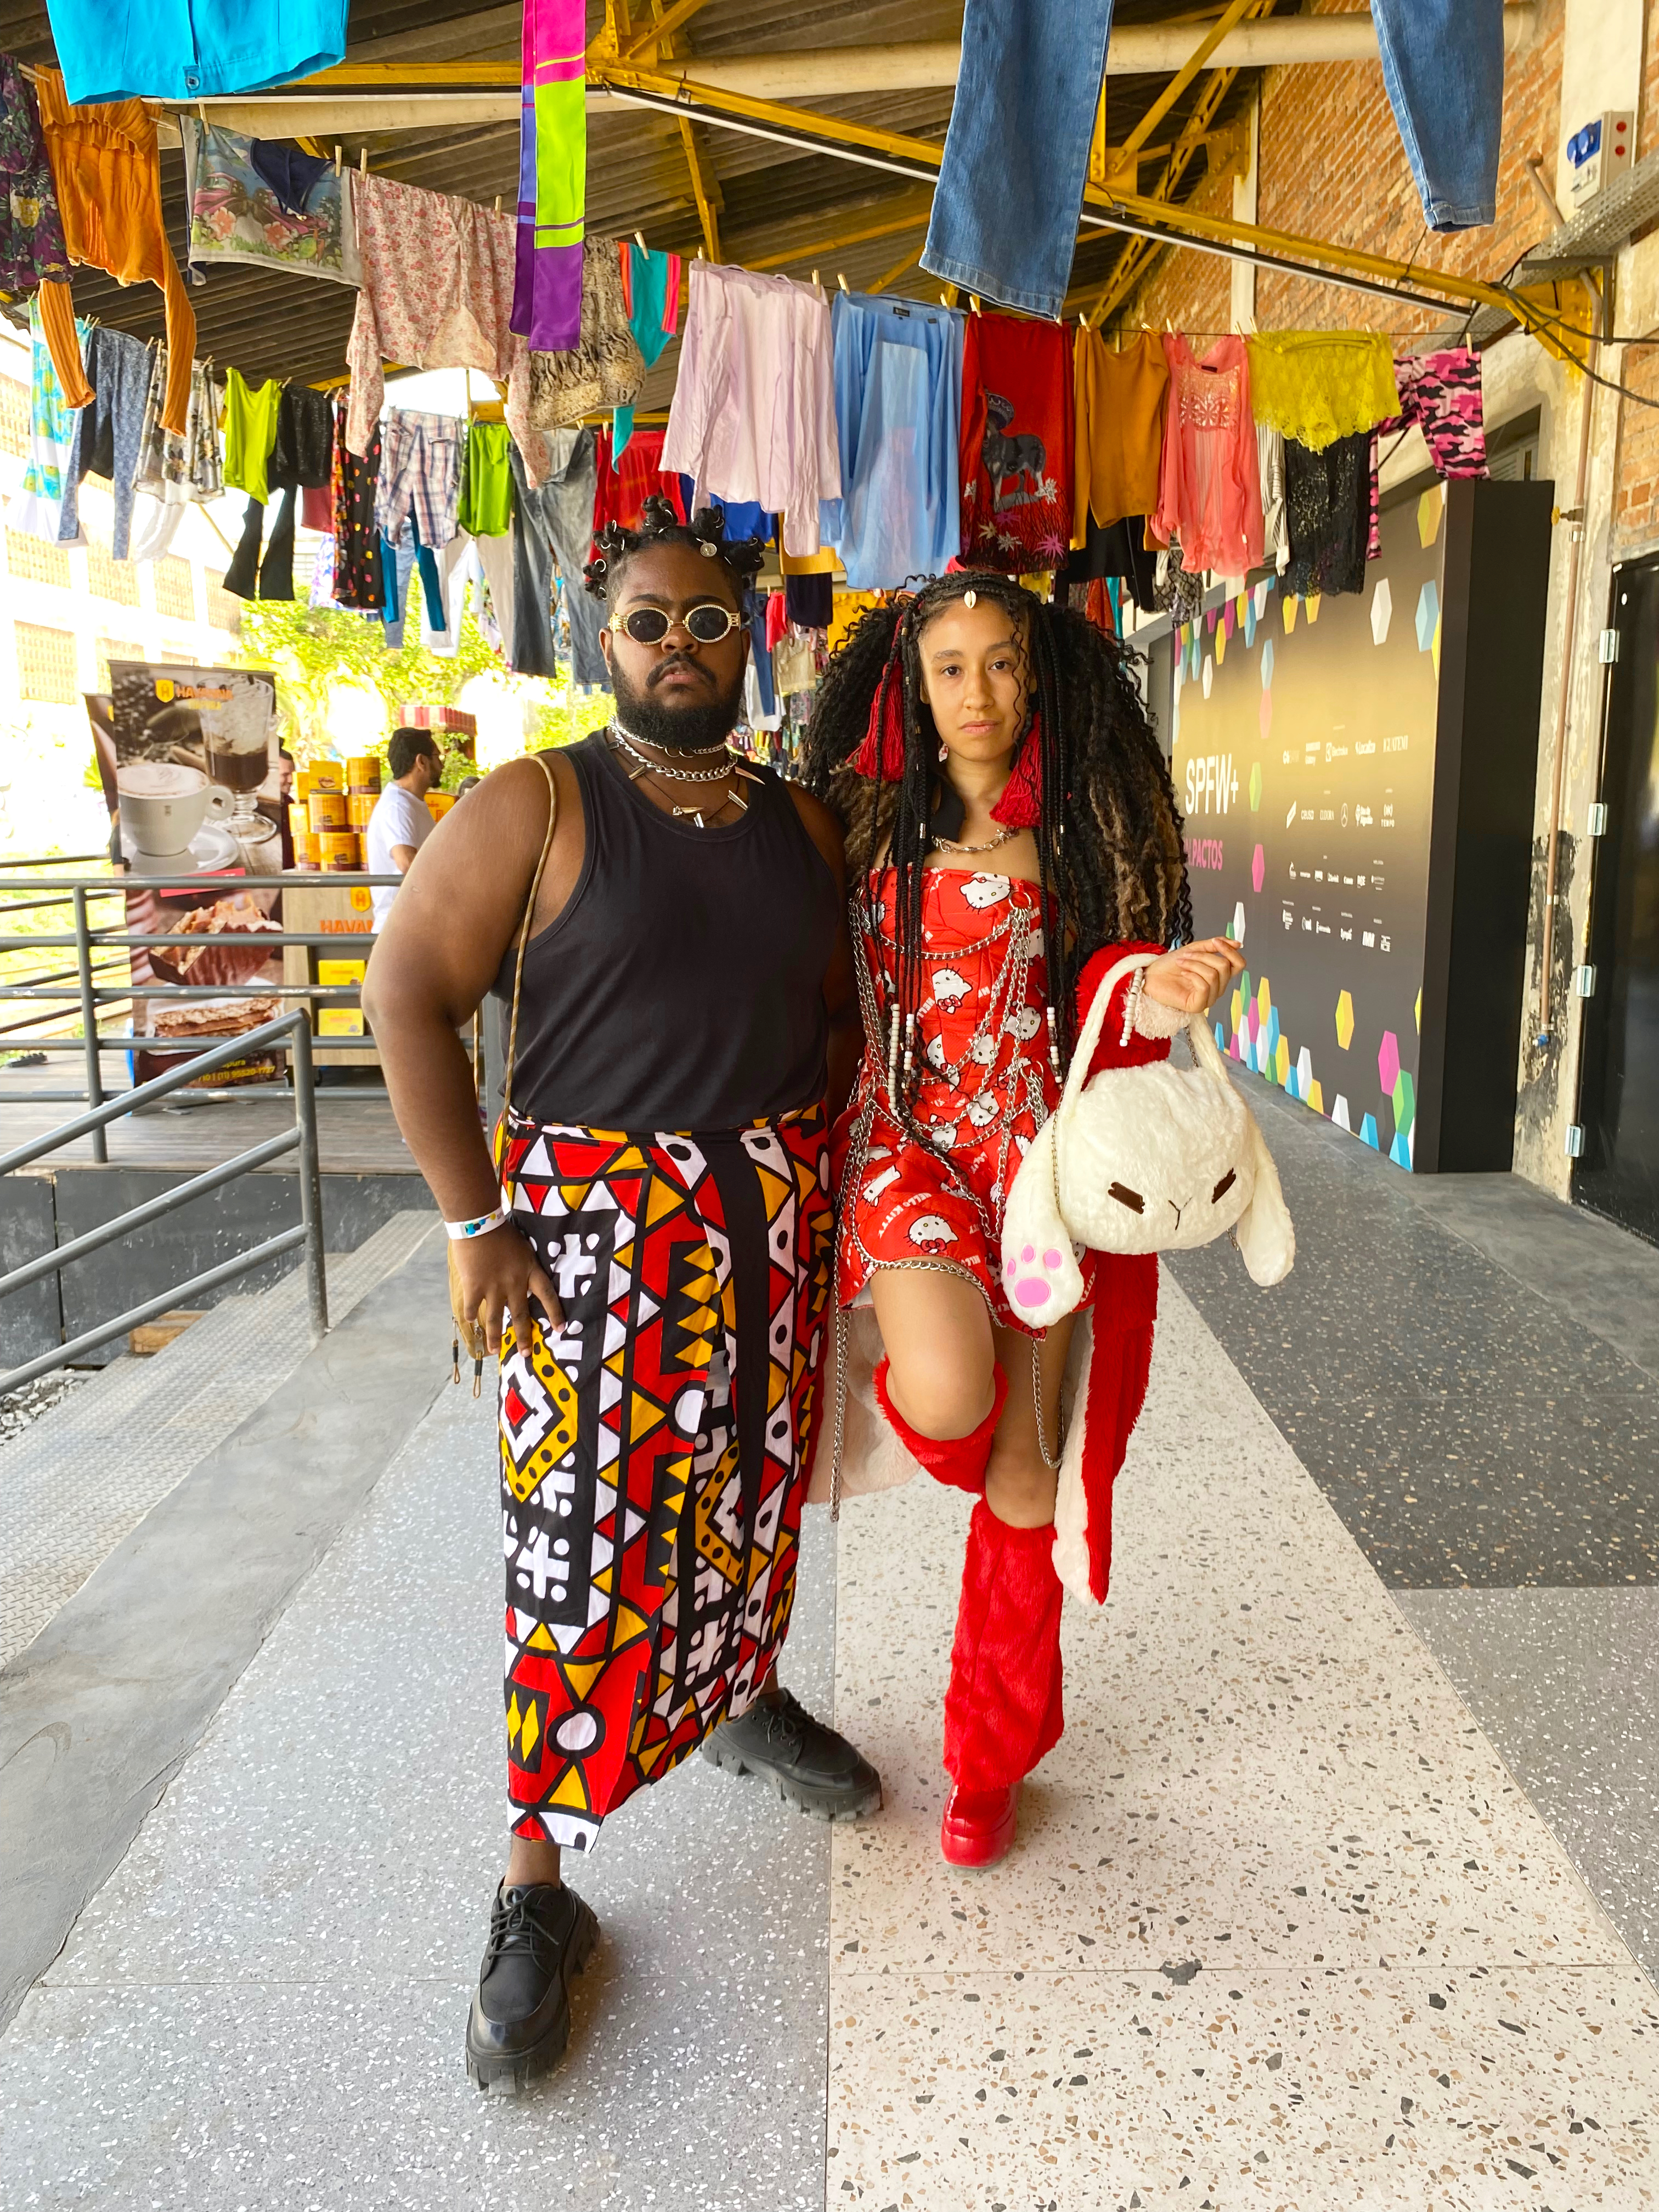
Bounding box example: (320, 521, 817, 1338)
(922, 0, 1113, 317)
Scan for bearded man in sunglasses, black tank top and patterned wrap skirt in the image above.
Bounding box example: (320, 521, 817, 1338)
(363, 500, 881, 2088)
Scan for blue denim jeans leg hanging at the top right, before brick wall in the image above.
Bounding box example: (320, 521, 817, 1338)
(1372, 0, 1504, 230)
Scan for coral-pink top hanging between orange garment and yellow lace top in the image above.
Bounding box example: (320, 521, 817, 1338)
(1153, 336, 1263, 575)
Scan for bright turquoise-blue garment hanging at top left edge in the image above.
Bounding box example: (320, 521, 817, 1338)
(47, 0, 347, 106)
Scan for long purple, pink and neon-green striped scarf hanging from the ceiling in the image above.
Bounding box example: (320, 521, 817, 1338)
(513, 0, 589, 354)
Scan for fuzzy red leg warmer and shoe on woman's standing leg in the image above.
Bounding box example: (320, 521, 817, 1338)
(940, 1500, 1066, 1867)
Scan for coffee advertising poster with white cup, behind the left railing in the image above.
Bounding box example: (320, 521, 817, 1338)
(109, 662, 283, 1088)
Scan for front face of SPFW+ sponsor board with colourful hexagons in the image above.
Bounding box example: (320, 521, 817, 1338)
(1172, 484, 1444, 1168)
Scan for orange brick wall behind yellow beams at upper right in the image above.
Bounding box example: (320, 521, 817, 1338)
(1121, 0, 1575, 336)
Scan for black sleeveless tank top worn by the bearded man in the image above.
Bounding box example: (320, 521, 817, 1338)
(495, 732, 840, 1130)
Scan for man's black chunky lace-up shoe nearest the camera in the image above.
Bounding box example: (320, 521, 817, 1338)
(467, 1882, 600, 2095)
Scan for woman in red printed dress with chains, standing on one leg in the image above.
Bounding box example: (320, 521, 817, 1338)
(805, 571, 1243, 1865)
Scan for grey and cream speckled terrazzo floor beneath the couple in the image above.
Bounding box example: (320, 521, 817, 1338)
(0, 1082, 1659, 2212)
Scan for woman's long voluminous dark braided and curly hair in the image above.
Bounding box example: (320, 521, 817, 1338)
(801, 568, 1192, 1092)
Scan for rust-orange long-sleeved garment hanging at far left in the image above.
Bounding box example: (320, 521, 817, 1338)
(36, 69, 197, 436)
